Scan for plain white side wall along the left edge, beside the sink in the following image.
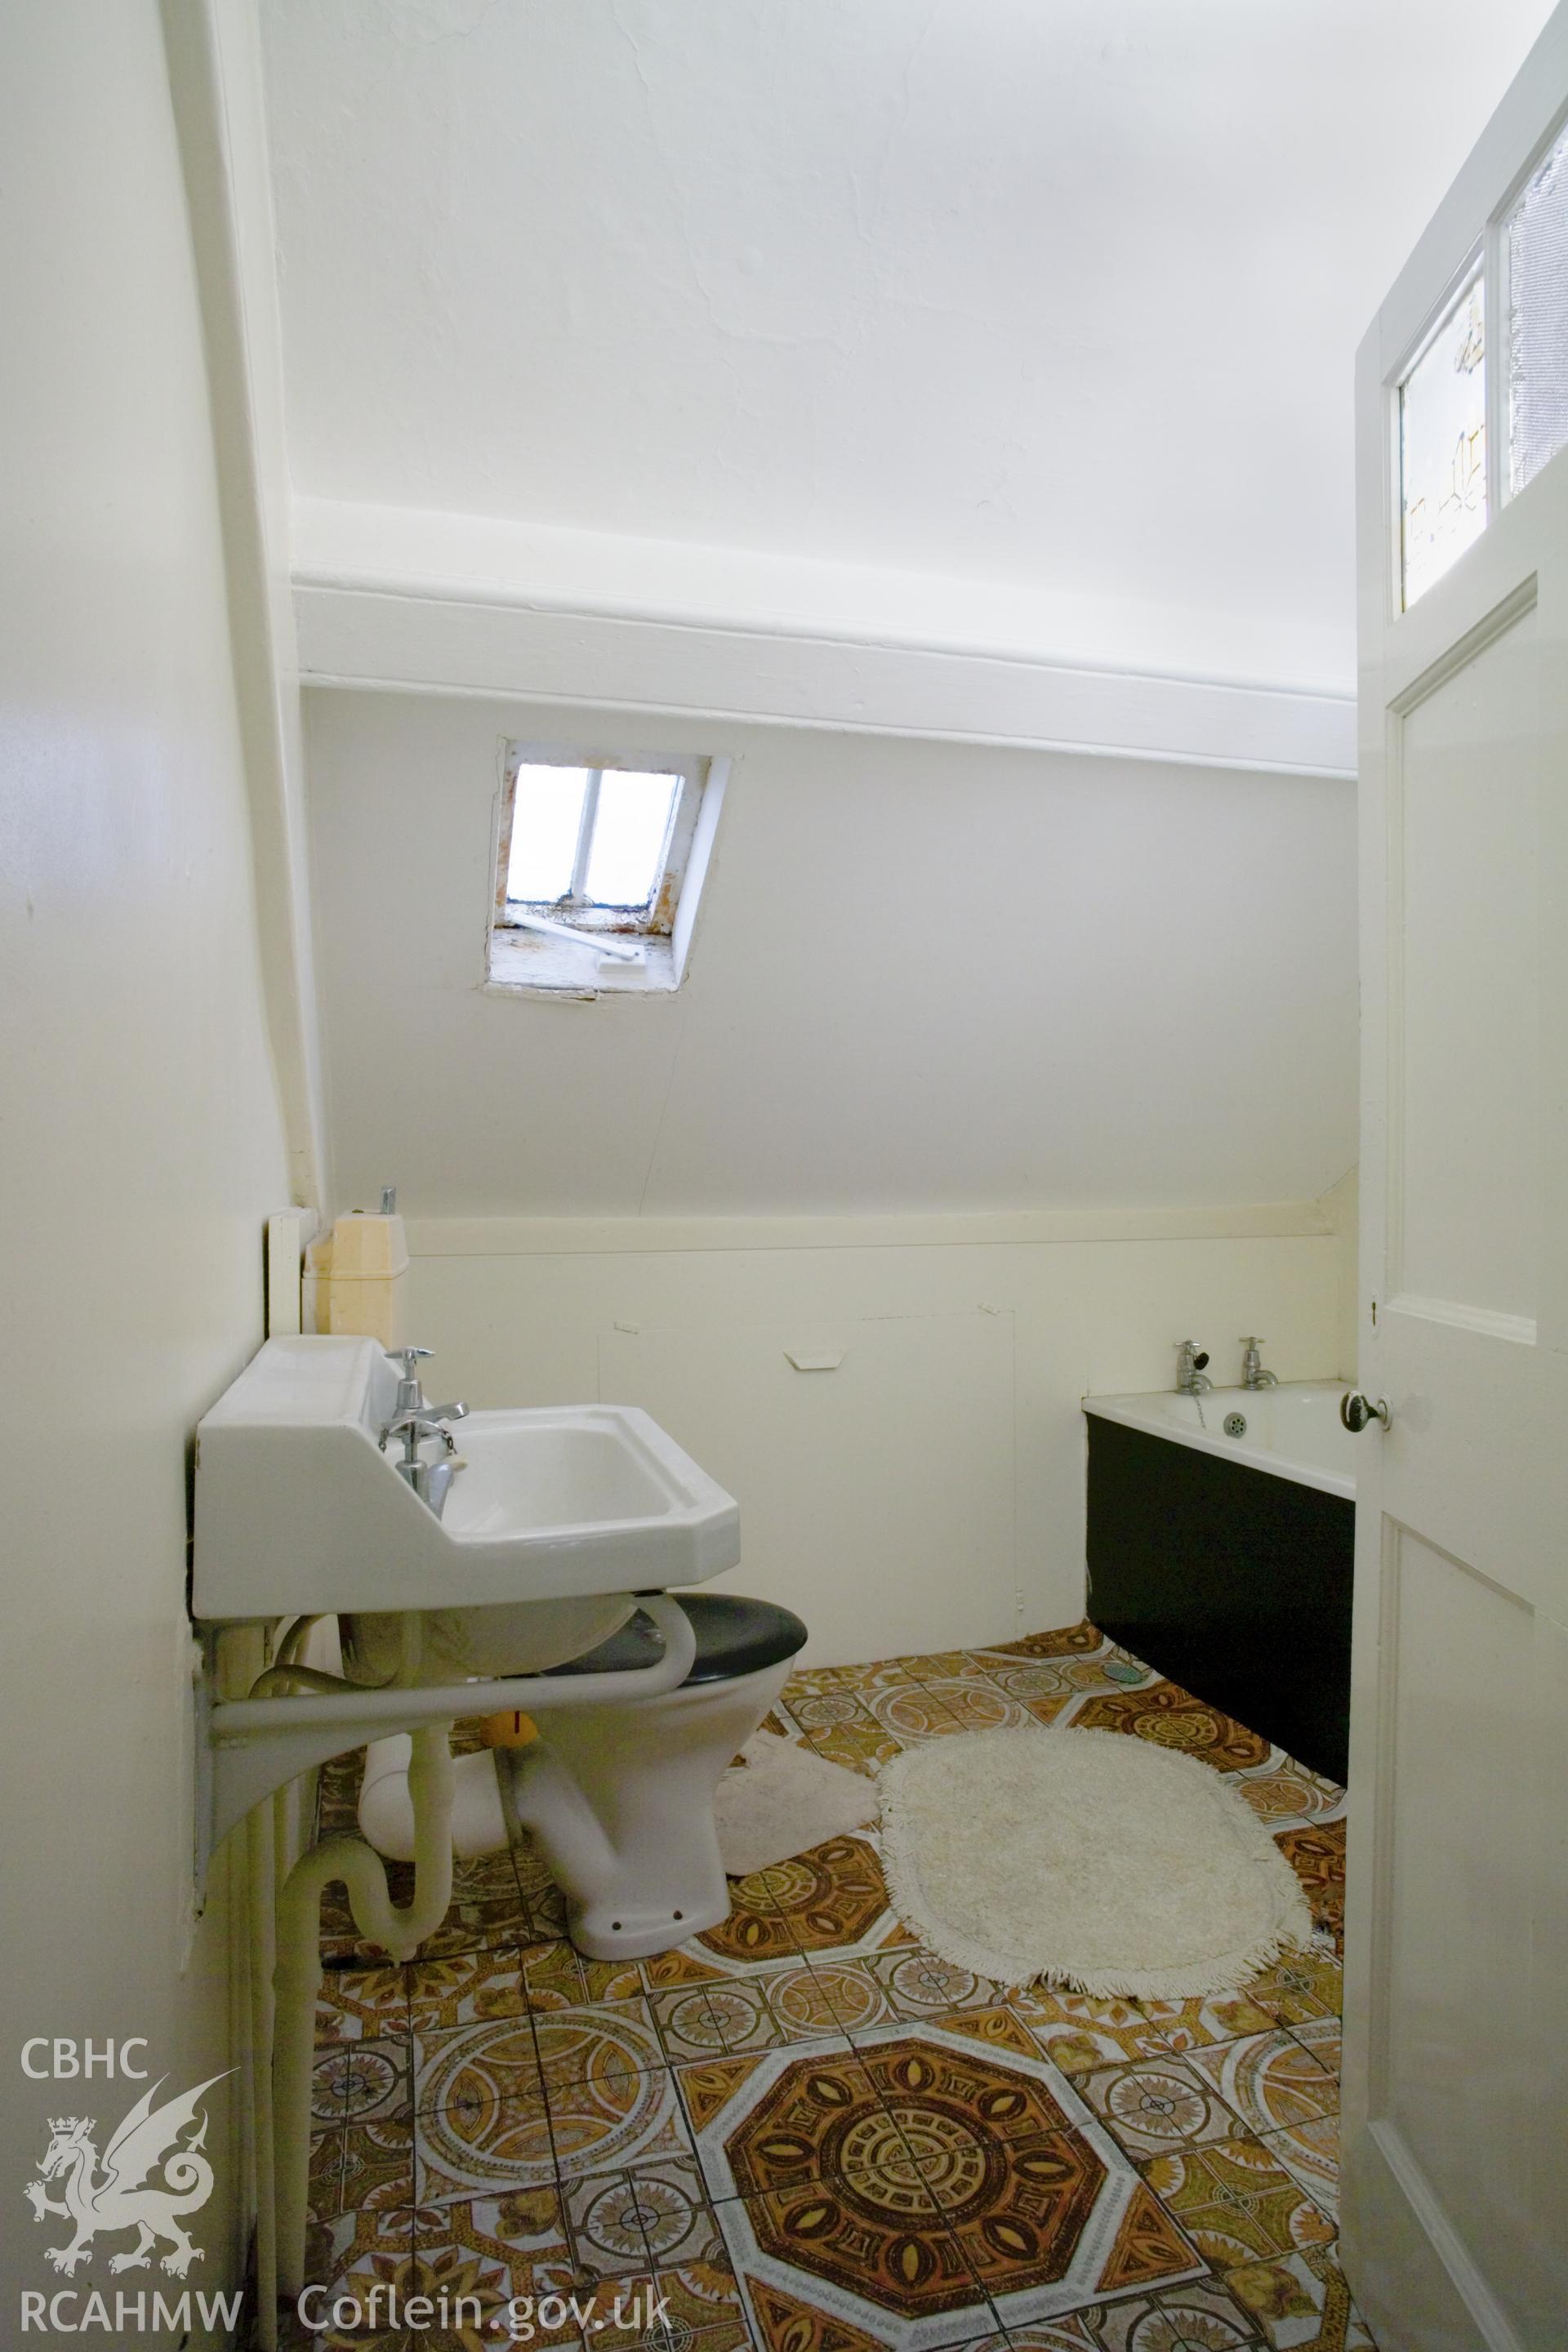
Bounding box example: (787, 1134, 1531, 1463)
(0, 0, 289, 2341)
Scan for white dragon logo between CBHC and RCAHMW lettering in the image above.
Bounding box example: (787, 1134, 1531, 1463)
(21, 2068, 233, 2279)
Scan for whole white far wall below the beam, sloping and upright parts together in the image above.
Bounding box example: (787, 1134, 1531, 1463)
(305, 689, 1356, 1660)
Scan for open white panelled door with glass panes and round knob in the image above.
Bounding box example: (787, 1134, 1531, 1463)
(1343, 7, 1568, 2352)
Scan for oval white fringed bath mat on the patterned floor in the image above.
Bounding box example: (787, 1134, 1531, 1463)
(880, 1724, 1312, 2002)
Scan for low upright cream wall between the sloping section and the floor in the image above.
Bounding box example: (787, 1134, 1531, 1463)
(409, 1206, 1340, 1663)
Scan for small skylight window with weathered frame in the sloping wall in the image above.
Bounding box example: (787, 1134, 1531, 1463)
(489, 746, 717, 995)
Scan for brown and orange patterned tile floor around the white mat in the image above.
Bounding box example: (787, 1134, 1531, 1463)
(308, 1623, 1375, 2352)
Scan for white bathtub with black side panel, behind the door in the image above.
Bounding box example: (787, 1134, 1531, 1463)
(1084, 1381, 1356, 1783)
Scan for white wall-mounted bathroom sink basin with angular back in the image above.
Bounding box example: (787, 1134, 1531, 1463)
(193, 1339, 741, 1679)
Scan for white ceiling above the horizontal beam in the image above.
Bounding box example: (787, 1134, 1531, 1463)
(261, 0, 1547, 687)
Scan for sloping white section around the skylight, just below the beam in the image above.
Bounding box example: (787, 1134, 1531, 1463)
(308, 692, 1356, 1214)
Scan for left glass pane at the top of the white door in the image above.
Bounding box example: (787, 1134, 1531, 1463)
(1399, 278, 1486, 612)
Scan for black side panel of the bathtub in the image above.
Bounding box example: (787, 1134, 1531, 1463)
(1086, 1411, 1356, 1780)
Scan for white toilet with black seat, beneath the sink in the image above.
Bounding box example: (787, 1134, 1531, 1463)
(359, 1592, 806, 1959)
